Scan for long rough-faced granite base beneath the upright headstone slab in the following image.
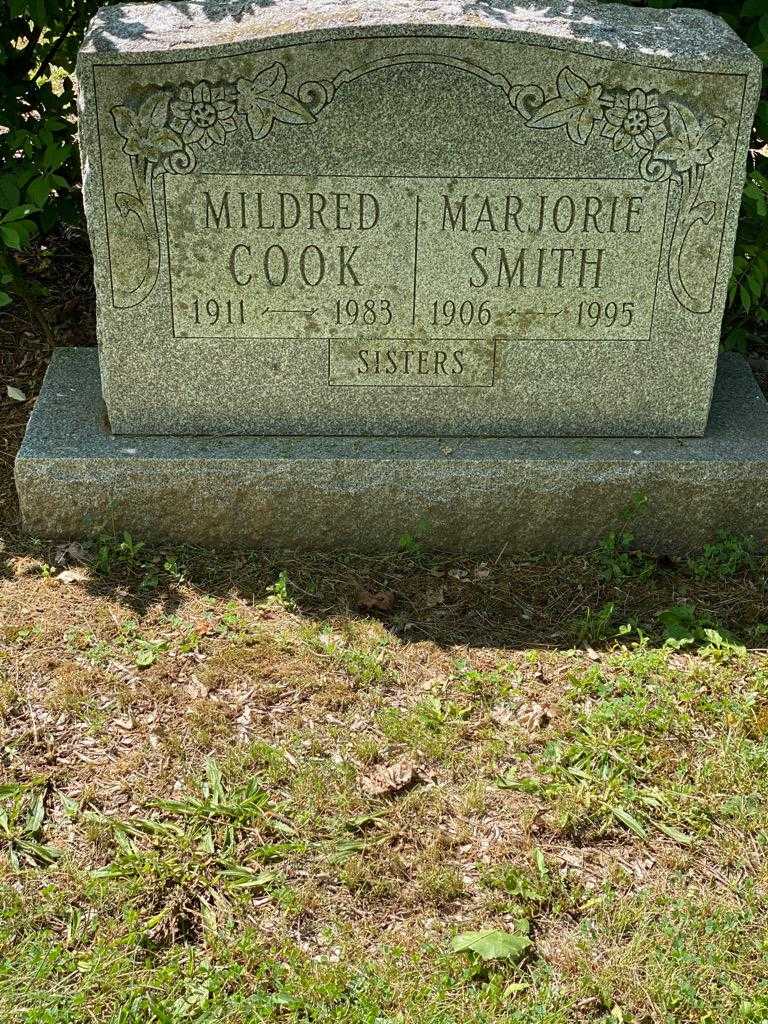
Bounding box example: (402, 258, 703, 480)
(15, 348, 768, 553)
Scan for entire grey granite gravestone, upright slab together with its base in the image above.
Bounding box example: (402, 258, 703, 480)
(16, 0, 768, 550)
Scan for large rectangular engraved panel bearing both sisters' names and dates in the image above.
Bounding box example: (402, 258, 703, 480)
(164, 174, 669, 350)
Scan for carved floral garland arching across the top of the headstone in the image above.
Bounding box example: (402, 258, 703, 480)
(111, 53, 725, 313)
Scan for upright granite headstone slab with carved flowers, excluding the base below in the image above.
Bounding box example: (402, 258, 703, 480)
(79, 0, 761, 435)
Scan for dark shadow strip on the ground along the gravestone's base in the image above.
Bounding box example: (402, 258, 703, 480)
(0, 532, 768, 649)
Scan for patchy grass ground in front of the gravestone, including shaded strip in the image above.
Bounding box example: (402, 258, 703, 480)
(0, 531, 768, 1024)
